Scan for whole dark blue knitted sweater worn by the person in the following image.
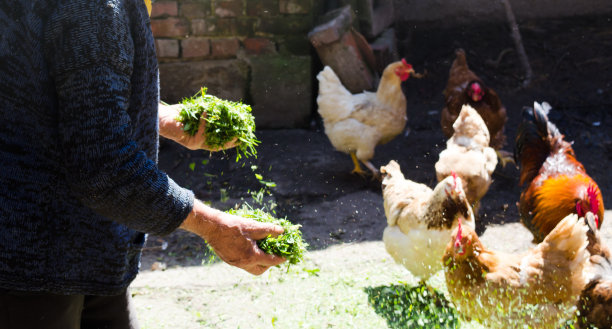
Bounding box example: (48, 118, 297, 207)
(0, 0, 193, 295)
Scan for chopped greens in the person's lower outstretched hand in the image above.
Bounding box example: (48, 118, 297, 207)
(228, 205, 308, 265)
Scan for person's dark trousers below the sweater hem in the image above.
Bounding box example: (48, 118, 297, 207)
(0, 290, 138, 329)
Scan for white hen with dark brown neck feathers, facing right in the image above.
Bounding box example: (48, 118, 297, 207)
(380, 160, 474, 282)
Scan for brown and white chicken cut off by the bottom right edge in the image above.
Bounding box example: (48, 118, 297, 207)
(576, 211, 612, 329)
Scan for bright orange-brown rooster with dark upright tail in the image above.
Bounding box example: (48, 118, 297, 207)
(514, 103, 604, 242)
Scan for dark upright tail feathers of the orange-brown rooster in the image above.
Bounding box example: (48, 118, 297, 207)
(514, 103, 558, 185)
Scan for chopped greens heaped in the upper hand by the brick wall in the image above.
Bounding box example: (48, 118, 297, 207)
(177, 88, 259, 161)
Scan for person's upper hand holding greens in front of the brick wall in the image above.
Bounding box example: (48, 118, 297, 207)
(159, 104, 238, 152)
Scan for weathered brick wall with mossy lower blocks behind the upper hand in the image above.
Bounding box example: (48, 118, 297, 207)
(151, 0, 319, 128)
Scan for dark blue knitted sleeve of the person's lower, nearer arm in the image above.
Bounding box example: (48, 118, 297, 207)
(45, 0, 194, 235)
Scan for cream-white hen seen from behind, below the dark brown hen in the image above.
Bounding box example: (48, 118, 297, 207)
(435, 105, 497, 213)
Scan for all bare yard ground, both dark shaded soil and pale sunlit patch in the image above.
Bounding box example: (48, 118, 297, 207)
(132, 17, 612, 329)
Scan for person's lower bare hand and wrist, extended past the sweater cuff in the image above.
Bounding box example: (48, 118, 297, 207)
(181, 201, 285, 275)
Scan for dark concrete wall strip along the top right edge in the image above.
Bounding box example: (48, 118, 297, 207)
(394, 0, 612, 26)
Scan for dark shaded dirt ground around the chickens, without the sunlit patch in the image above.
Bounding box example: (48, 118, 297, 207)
(142, 17, 612, 271)
